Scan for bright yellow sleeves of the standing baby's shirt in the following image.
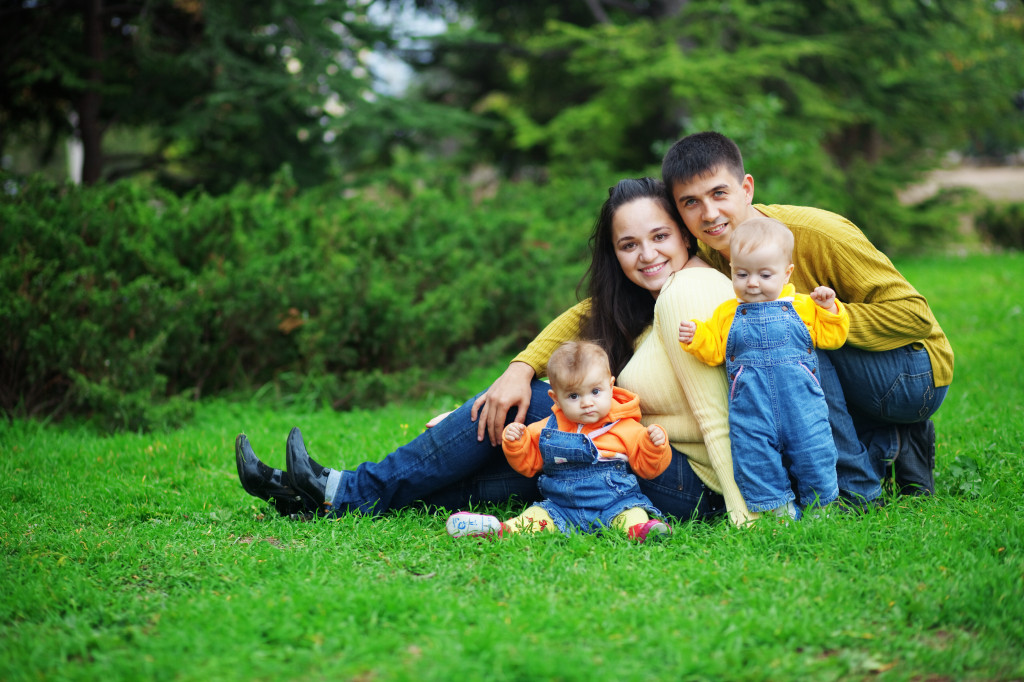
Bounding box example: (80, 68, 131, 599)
(681, 284, 850, 365)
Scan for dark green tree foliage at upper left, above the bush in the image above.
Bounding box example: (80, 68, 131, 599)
(0, 0, 479, 191)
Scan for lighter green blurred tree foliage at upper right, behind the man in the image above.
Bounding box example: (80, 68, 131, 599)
(407, 0, 1024, 173)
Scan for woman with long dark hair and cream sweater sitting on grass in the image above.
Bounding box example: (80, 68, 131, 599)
(236, 178, 750, 523)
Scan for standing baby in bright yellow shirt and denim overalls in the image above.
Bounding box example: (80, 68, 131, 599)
(679, 217, 850, 518)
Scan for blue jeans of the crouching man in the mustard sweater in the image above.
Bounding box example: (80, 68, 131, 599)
(817, 344, 948, 501)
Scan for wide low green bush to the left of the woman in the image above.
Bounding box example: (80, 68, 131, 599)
(0, 163, 610, 429)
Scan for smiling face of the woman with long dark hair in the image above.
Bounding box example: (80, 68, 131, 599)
(611, 193, 689, 298)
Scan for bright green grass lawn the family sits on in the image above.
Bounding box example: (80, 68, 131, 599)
(0, 254, 1024, 682)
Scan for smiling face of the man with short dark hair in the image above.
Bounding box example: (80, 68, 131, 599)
(672, 166, 754, 258)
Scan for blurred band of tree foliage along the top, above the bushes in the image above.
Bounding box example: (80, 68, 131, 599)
(6, 0, 1024, 195)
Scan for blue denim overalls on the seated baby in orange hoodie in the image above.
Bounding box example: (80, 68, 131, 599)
(537, 415, 663, 534)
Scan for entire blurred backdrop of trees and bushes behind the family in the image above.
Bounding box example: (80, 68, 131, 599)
(0, 0, 1024, 428)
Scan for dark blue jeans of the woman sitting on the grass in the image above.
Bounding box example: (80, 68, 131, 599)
(329, 380, 725, 519)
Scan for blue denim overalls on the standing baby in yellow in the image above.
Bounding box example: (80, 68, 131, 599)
(725, 298, 839, 511)
